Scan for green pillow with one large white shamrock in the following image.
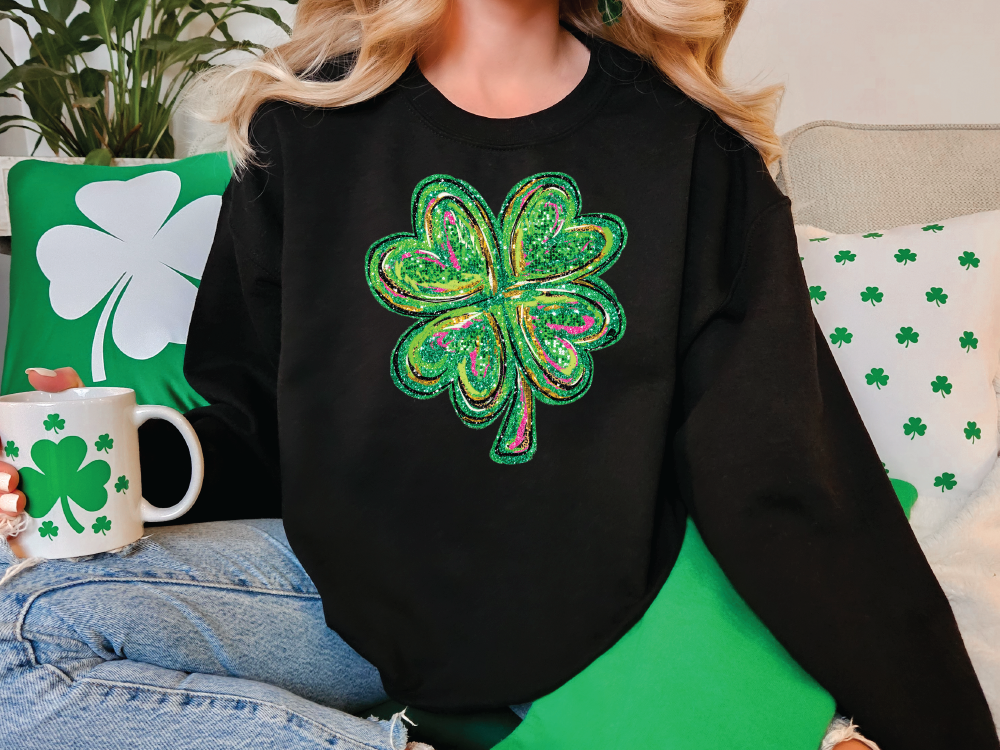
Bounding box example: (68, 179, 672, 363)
(3, 153, 230, 410)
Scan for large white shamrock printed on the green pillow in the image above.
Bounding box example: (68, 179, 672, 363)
(37, 171, 222, 383)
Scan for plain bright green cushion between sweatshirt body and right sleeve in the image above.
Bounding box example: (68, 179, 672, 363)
(496, 520, 834, 750)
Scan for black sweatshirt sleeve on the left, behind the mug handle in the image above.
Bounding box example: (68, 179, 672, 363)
(140, 111, 283, 523)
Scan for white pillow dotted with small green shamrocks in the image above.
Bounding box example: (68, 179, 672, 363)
(796, 211, 1000, 524)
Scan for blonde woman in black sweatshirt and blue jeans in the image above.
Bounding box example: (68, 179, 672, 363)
(0, 0, 998, 750)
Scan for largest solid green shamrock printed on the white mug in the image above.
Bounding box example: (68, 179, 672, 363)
(21, 435, 111, 534)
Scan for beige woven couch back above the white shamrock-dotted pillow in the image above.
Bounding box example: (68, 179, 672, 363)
(778, 120, 1000, 234)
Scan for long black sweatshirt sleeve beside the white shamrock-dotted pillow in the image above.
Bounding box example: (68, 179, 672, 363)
(674, 120, 1000, 750)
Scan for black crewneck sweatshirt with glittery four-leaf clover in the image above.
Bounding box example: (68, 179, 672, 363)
(143, 33, 1000, 750)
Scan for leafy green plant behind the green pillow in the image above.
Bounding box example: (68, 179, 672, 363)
(0, 0, 296, 164)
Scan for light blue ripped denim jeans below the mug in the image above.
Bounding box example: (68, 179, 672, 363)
(0, 520, 407, 750)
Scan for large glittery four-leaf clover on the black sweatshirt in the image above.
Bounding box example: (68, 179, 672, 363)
(366, 172, 627, 464)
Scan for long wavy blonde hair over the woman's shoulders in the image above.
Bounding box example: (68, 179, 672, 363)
(202, 0, 781, 167)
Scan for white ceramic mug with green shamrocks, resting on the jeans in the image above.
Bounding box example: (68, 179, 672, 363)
(0, 388, 205, 558)
